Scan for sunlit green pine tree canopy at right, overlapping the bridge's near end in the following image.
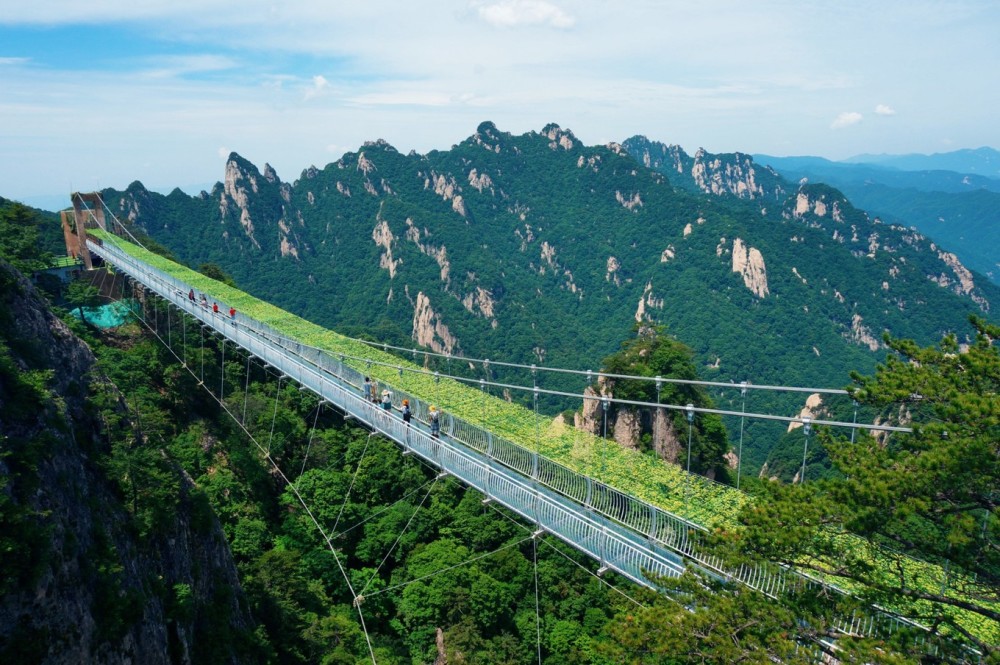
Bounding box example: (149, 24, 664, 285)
(739, 317, 1000, 662)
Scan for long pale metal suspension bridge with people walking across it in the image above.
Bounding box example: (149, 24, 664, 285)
(64, 195, 984, 660)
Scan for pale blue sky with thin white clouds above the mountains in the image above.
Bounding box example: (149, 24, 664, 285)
(0, 0, 1000, 210)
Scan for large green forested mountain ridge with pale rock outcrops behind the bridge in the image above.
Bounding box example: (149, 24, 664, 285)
(104, 122, 1000, 472)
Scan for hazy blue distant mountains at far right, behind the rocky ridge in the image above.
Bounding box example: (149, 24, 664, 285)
(755, 151, 1000, 283)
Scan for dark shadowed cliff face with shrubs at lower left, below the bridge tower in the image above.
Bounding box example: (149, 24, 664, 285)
(0, 262, 253, 663)
